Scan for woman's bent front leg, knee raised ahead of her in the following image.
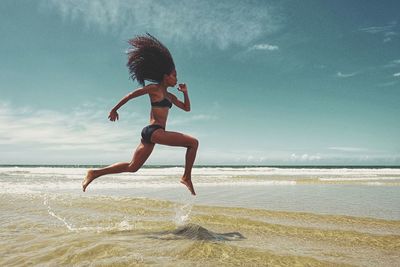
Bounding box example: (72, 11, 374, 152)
(151, 129, 199, 195)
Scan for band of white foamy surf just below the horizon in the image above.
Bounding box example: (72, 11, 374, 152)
(0, 167, 400, 194)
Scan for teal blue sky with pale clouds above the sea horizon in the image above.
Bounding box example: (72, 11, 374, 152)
(0, 0, 400, 165)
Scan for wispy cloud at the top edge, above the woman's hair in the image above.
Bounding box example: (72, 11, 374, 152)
(41, 0, 282, 49)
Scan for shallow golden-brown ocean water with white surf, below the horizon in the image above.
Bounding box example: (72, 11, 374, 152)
(0, 165, 400, 266)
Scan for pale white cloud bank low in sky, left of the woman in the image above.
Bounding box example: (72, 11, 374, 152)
(0, 103, 145, 157)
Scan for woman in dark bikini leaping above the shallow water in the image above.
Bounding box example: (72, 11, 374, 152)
(82, 33, 199, 195)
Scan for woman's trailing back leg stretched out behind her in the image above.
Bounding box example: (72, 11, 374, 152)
(82, 142, 154, 192)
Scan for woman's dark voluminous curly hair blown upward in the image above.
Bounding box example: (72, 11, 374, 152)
(126, 33, 175, 86)
